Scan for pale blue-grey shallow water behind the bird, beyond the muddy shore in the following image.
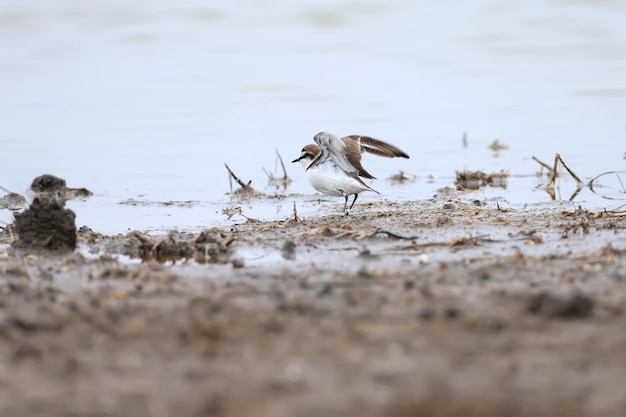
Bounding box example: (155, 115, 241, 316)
(0, 0, 626, 233)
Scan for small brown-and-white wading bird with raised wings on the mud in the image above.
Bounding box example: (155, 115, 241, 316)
(291, 132, 409, 214)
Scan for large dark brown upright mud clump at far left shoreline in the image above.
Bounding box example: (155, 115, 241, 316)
(13, 198, 76, 251)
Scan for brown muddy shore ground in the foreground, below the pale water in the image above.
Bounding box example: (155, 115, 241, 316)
(0, 195, 626, 417)
